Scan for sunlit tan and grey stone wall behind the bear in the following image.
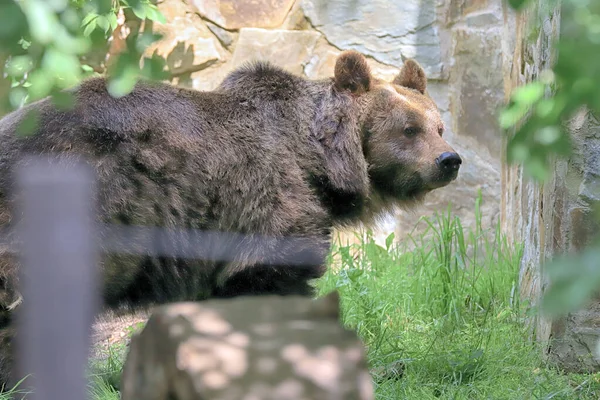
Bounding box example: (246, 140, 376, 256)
(151, 0, 505, 244)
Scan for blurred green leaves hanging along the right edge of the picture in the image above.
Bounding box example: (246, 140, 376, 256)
(500, 0, 600, 315)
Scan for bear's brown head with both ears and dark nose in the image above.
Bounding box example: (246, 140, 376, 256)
(333, 51, 462, 204)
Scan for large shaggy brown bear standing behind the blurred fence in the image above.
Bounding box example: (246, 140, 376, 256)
(0, 51, 461, 388)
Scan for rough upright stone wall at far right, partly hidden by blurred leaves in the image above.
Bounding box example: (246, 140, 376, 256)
(501, 0, 600, 371)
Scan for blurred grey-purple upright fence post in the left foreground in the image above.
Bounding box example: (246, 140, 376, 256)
(17, 158, 98, 400)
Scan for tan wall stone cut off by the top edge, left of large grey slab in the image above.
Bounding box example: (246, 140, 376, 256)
(191, 0, 294, 30)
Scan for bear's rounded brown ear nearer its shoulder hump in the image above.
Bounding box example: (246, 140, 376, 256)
(334, 50, 372, 95)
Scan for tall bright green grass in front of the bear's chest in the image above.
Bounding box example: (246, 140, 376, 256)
(318, 195, 600, 400)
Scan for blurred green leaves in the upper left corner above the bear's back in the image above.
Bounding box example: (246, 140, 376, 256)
(0, 0, 168, 115)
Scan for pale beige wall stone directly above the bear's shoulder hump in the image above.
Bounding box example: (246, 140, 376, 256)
(229, 28, 321, 74)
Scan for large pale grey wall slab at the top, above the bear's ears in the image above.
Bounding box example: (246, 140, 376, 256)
(301, 0, 443, 79)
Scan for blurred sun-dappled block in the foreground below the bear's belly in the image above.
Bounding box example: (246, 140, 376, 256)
(122, 296, 374, 400)
